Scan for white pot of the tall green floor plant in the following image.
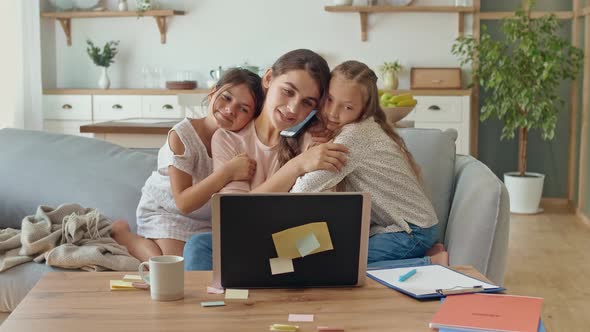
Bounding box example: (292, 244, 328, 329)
(504, 172, 545, 214)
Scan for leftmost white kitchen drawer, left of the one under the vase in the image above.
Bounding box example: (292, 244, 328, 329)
(43, 95, 92, 121)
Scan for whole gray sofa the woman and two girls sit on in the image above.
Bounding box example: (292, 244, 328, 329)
(0, 129, 509, 311)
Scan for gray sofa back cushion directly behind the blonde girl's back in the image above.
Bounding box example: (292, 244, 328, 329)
(398, 128, 457, 242)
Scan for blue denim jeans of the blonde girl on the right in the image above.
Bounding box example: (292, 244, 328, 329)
(367, 224, 438, 268)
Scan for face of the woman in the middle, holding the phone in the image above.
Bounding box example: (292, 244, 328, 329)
(262, 70, 320, 130)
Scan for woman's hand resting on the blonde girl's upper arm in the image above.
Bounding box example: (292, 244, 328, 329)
(292, 143, 348, 175)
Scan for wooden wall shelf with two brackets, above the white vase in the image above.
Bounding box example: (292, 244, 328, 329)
(41, 9, 184, 46)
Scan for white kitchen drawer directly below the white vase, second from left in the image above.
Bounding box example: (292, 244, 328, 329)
(92, 96, 141, 122)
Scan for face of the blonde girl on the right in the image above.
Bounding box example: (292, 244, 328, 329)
(322, 74, 364, 131)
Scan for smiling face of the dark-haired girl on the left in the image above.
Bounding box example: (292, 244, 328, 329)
(211, 84, 255, 131)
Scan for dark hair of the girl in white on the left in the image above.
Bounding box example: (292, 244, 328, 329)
(207, 68, 265, 117)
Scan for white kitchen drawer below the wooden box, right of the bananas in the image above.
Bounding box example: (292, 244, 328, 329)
(413, 96, 463, 122)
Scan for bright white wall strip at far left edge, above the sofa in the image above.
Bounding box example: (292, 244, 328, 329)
(0, 1, 24, 128)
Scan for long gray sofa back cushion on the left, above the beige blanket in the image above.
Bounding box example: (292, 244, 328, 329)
(0, 129, 157, 230)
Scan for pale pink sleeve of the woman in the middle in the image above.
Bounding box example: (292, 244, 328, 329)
(211, 129, 251, 193)
